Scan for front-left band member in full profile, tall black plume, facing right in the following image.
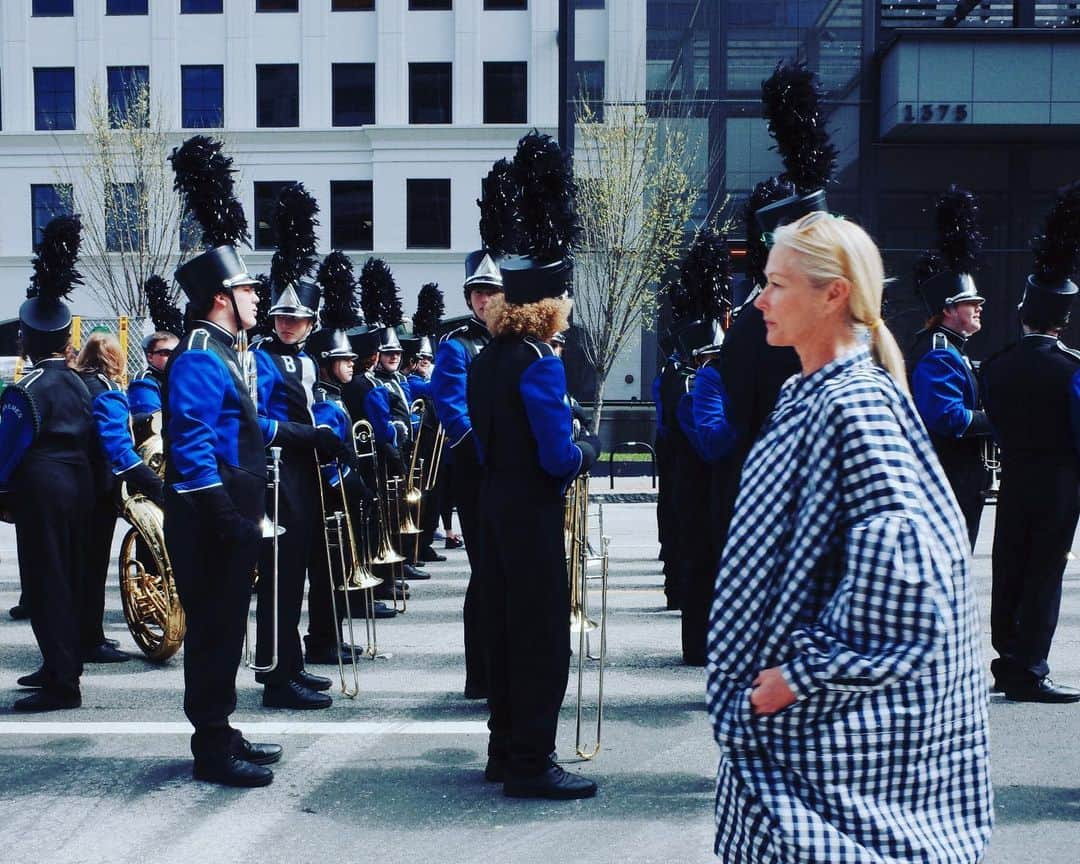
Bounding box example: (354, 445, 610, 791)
(162, 135, 281, 786)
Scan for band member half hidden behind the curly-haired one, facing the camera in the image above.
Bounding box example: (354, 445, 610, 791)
(431, 249, 502, 699)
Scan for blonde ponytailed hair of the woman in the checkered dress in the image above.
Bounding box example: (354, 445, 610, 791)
(772, 211, 908, 393)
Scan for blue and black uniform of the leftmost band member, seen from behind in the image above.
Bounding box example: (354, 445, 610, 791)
(0, 357, 96, 697)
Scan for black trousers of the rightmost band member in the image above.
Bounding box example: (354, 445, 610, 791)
(990, 457, 1080, 684)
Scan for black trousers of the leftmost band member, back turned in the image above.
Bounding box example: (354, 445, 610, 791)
(9, 451, 93, 692)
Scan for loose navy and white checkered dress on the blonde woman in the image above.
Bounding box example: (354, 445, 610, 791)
(708, 348, 993, 864)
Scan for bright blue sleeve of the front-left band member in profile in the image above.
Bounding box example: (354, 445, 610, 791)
(166, 351, 232, 492)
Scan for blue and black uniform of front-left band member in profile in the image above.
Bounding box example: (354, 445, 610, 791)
(162, 321, 275, 765)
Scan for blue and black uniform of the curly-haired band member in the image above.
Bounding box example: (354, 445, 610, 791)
(468, 336, 595, 777)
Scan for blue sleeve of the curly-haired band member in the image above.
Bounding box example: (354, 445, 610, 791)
(517, 356, 582, 481)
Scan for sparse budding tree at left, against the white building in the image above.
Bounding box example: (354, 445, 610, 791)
(52, 82, 186, 318)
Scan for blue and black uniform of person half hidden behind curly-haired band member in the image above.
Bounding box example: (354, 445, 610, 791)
(431, 318, 491, 697)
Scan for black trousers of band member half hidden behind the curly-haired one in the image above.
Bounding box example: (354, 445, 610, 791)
(453, 435, 488, 694)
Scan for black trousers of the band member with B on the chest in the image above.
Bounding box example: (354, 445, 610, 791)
(255, 450, 319, 684)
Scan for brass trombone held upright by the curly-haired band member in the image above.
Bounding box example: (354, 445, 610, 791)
(563, 474, 609, 759)
